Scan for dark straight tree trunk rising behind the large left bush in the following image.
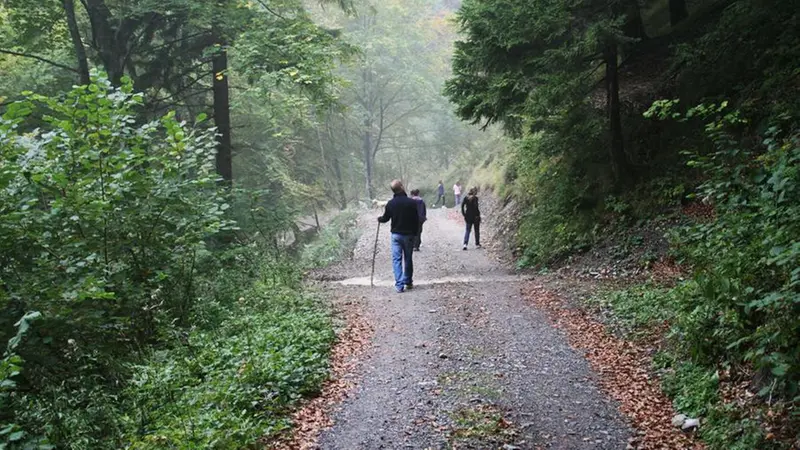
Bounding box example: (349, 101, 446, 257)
(211, 44, 233, 184)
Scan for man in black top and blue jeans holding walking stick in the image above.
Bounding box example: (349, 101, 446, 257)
(378, 180, 419, 293)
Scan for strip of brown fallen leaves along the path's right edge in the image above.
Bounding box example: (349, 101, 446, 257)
(523, 283, 704, 450)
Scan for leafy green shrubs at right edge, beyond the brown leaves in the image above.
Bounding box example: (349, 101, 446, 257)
(595, 101, 800, 449)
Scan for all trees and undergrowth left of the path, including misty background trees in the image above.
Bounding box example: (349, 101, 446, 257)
(0, 0, 480, 449)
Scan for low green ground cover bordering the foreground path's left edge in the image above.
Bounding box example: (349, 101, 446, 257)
(123, 283, 335, 449)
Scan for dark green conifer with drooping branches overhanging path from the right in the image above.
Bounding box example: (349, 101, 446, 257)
(445, 0, 638, 176)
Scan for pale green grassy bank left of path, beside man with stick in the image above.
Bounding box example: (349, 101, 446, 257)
(301, 210, 359, 268)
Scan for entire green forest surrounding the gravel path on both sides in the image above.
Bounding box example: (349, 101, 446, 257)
(0, 0, 800, 450)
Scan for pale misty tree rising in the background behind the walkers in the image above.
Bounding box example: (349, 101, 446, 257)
(324, 0, 444, 198)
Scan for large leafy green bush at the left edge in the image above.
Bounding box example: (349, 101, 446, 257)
(0, 75, 229, 447)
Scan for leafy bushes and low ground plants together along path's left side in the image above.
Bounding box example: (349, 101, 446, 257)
(0, 75, 334, 448)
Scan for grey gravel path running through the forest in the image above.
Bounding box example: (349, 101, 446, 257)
(319, 209, 631, 450)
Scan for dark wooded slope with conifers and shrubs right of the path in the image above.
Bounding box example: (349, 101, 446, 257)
(446, 0, 800, 449)
